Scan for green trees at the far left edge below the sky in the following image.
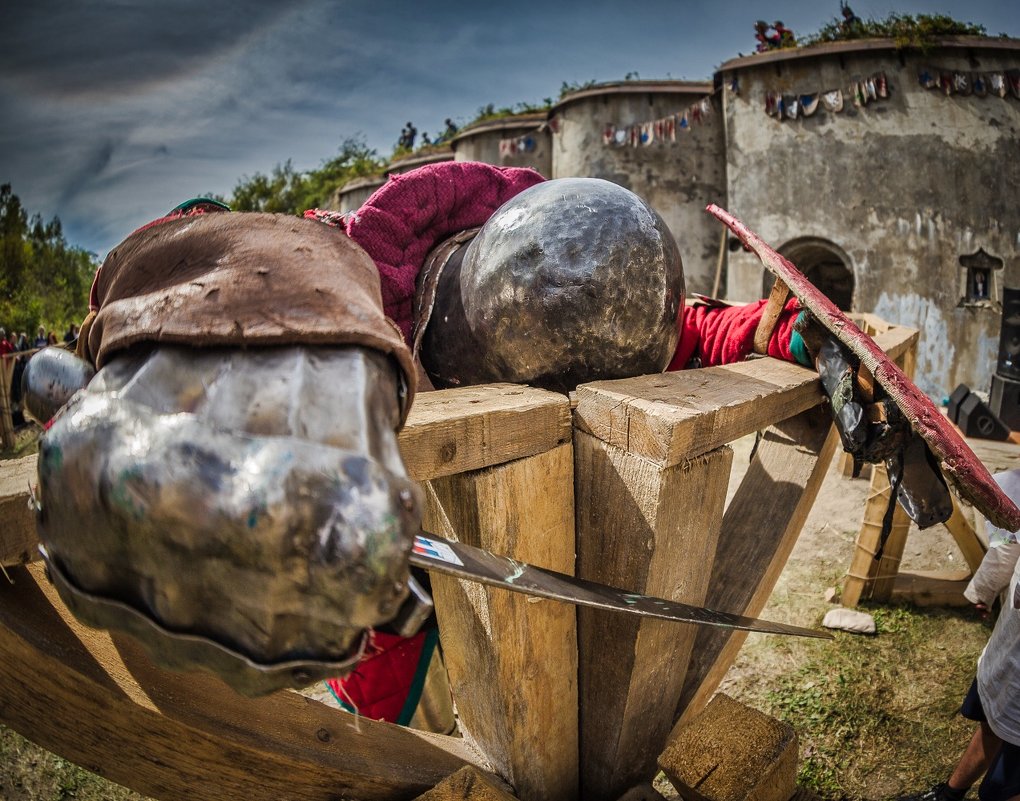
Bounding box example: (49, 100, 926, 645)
(0, 184, 98, 337)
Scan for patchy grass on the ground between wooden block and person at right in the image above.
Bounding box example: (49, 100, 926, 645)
(754, 606, 989, 801)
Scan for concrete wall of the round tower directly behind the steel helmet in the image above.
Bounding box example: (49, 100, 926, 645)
(551, 81, 726, 294)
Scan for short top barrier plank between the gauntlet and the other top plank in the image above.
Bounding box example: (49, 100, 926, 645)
(400, 384, 571, 481)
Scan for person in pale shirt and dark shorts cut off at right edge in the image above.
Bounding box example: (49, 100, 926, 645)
(899, 469, 1020, 801)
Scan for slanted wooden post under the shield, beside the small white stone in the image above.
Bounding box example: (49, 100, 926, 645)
(839, 464, 910, 607)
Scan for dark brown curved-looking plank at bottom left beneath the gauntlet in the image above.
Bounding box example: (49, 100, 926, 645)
(0, 564, 482, 801)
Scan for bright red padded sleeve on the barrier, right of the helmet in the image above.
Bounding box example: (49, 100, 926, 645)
(667, 298, 801, 370)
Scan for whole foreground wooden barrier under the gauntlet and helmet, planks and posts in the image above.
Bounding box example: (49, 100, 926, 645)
(0, 326, 918, 801)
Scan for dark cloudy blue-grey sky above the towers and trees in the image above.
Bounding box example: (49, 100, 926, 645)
(0, 0, 1020, 256)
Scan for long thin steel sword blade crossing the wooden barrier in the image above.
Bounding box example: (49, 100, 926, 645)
(411, 534, 832, 639)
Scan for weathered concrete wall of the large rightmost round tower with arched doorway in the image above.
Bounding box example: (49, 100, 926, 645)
(720, 39, 1020, 399)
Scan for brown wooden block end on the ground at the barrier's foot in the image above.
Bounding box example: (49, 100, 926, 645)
(659, 693, 798, 801)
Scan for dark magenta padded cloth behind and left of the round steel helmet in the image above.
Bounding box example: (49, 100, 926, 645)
(334, 161, 545, 344)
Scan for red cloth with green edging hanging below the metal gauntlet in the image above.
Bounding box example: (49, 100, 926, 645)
(326, 630, 426, 723)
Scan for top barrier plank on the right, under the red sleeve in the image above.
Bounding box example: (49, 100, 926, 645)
(574, 358, 823, 466)
